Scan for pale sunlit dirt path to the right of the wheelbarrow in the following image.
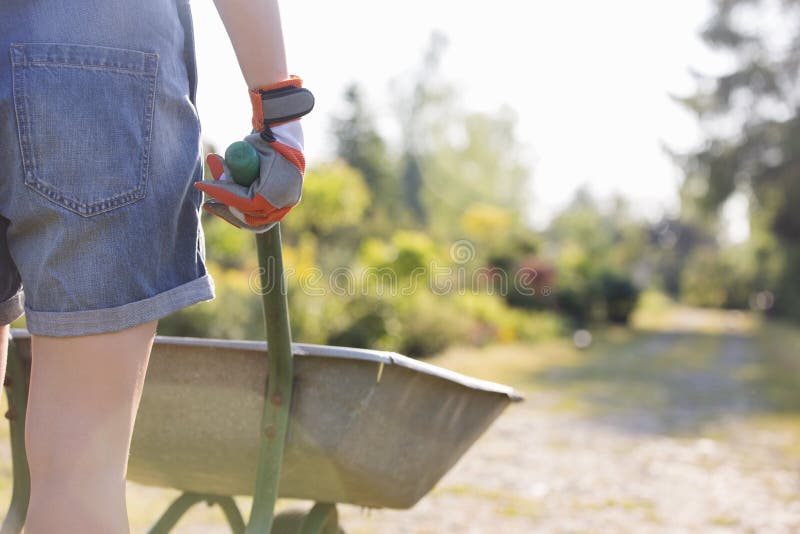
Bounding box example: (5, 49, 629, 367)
(340, 333, 800, 534)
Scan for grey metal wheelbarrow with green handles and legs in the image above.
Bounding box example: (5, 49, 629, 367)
(0, 225, 522, 534)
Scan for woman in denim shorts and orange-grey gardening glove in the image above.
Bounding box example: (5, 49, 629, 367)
(0, 0, 310, 534)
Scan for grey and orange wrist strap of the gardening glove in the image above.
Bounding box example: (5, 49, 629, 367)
(249, 76, 314, 132)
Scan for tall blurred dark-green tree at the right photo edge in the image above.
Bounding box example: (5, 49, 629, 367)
(681, 0, 800, 318)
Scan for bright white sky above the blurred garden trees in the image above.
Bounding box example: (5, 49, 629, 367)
(192, 0, 746, 239)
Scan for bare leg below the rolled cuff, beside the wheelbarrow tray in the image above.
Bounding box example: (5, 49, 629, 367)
(25, 321, 156, 534)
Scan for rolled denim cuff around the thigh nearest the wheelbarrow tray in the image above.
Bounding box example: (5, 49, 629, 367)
(25, 274, 214, 337)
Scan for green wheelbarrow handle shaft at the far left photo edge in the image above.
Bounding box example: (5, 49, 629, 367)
(0, 340, 31, 534)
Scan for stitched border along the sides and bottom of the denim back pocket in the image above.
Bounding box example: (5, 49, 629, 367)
(11, 43, 159, 217)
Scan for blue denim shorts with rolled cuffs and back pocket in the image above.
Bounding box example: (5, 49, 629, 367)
(0, 0, 214, 336)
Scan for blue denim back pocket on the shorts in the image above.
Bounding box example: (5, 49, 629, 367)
(11, 43, 158, 217)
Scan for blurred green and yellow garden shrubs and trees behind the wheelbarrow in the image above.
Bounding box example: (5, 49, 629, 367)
(160, 25, 800, 357)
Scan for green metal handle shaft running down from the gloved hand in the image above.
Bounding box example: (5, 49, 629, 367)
(246, 224, 292, 534)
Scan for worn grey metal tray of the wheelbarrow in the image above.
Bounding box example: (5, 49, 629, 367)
(12, 330, 521, 508)
